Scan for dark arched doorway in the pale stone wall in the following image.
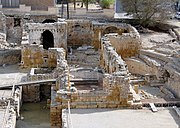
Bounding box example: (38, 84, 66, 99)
(42, 30, 54, 50)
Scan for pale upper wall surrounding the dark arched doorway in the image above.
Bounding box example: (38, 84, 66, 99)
(26, 22, 67, 49)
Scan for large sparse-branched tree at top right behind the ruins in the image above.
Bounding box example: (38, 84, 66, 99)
(121, 0, 174, 26)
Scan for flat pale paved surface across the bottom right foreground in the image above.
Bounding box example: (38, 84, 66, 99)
(71, 108, 180, 128)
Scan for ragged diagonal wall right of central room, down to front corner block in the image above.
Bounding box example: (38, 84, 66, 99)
(101, 36, 131, 104)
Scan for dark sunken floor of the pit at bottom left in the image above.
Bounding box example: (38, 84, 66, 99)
(16, 103, 50, 128)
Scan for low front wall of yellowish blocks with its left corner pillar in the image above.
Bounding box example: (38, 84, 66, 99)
(50, 88, 130, 128)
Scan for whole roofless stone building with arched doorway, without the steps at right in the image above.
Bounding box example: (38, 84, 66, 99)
(17, 20, 142, 126)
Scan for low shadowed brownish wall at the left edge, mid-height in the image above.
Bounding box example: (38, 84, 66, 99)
(0, 49, 21, 65)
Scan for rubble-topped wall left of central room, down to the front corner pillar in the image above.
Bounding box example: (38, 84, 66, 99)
(50, 49, 69, 128)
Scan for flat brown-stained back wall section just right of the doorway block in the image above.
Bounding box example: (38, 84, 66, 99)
(67, 20, 93, 47)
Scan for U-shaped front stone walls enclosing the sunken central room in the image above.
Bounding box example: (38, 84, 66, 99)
(51, 26, 142, 127)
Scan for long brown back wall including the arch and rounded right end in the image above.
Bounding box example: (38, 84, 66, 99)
(66, 19, 140, 49)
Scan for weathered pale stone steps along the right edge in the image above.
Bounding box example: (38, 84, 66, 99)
(136, 50, 180, 97)
